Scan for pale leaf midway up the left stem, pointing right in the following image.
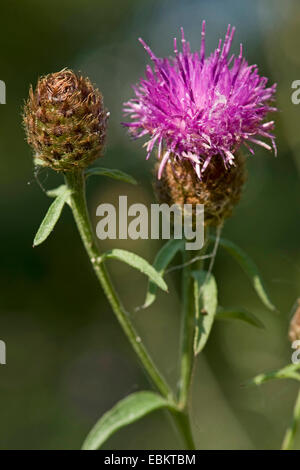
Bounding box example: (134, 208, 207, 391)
(102, 248, 168, 291)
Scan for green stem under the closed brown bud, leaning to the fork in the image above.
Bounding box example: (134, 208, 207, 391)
(65, 170, 174, 402)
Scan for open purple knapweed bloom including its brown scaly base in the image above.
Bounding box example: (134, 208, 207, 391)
(124, 22, 276, 226)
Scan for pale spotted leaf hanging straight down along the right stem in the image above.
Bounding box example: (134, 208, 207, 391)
(192, 271, 218, 355)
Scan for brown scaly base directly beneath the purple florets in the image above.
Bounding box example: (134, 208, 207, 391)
(154, 152, 247, 227)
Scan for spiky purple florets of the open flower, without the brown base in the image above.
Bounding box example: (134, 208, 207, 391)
(124, 22, 277, 178)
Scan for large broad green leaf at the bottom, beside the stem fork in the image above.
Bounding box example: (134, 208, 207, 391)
(82, 392, 172, 450)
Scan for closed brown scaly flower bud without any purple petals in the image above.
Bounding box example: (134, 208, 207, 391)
(24, 69, 109, 171)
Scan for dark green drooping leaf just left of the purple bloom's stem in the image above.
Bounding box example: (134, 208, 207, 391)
(141, 239, 185, 308)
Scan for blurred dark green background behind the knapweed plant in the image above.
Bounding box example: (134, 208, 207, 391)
(0, 0, 300, 449)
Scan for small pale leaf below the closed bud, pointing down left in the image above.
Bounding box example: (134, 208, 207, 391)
(33, 188, 70, 246)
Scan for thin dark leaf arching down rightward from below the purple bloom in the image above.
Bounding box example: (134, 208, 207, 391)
(211, 237, 276, 311)
